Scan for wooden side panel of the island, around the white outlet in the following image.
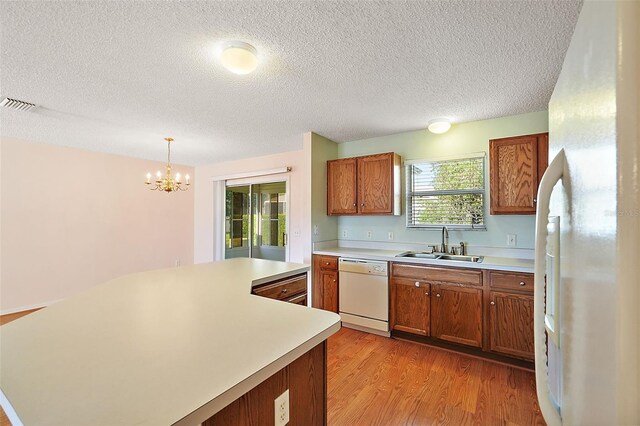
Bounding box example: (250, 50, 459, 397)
(202, 342, 327, 426)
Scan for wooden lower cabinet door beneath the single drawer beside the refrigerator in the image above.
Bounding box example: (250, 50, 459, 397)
(490, 291, 534, 360)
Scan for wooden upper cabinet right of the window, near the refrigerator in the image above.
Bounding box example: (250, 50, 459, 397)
(489, 133, 549, 214)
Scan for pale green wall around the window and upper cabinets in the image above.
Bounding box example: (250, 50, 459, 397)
(338, 111, 549, 249)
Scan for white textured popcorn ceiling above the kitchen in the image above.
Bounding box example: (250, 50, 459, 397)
(0, 0, 581, 165)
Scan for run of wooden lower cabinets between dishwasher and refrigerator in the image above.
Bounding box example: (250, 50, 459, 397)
(389, 262, 534, 368)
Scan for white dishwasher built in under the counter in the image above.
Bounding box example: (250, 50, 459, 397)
(338, 257, 390, 336)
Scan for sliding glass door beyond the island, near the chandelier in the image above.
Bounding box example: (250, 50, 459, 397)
(224, 181, 288, 261)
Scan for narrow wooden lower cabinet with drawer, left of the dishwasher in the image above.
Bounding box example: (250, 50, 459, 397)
(312, 255, 339, 313)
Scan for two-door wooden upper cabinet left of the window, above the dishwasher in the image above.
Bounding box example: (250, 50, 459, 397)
(327, 152, 401, 215)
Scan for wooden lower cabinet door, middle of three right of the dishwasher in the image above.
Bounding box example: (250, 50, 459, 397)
(431, 284, 482, 348)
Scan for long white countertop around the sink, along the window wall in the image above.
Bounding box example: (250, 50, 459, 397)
(313, 246, 533, 273)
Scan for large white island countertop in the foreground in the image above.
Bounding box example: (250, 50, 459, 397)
(0, 259, 340, 425)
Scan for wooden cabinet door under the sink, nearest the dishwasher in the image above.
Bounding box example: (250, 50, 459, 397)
(391, 278, 431, 336)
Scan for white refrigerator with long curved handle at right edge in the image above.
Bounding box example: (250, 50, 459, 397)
(534, 1, 640, 426)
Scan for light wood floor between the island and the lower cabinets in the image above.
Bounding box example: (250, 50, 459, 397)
(327, 327, 545, 426)
